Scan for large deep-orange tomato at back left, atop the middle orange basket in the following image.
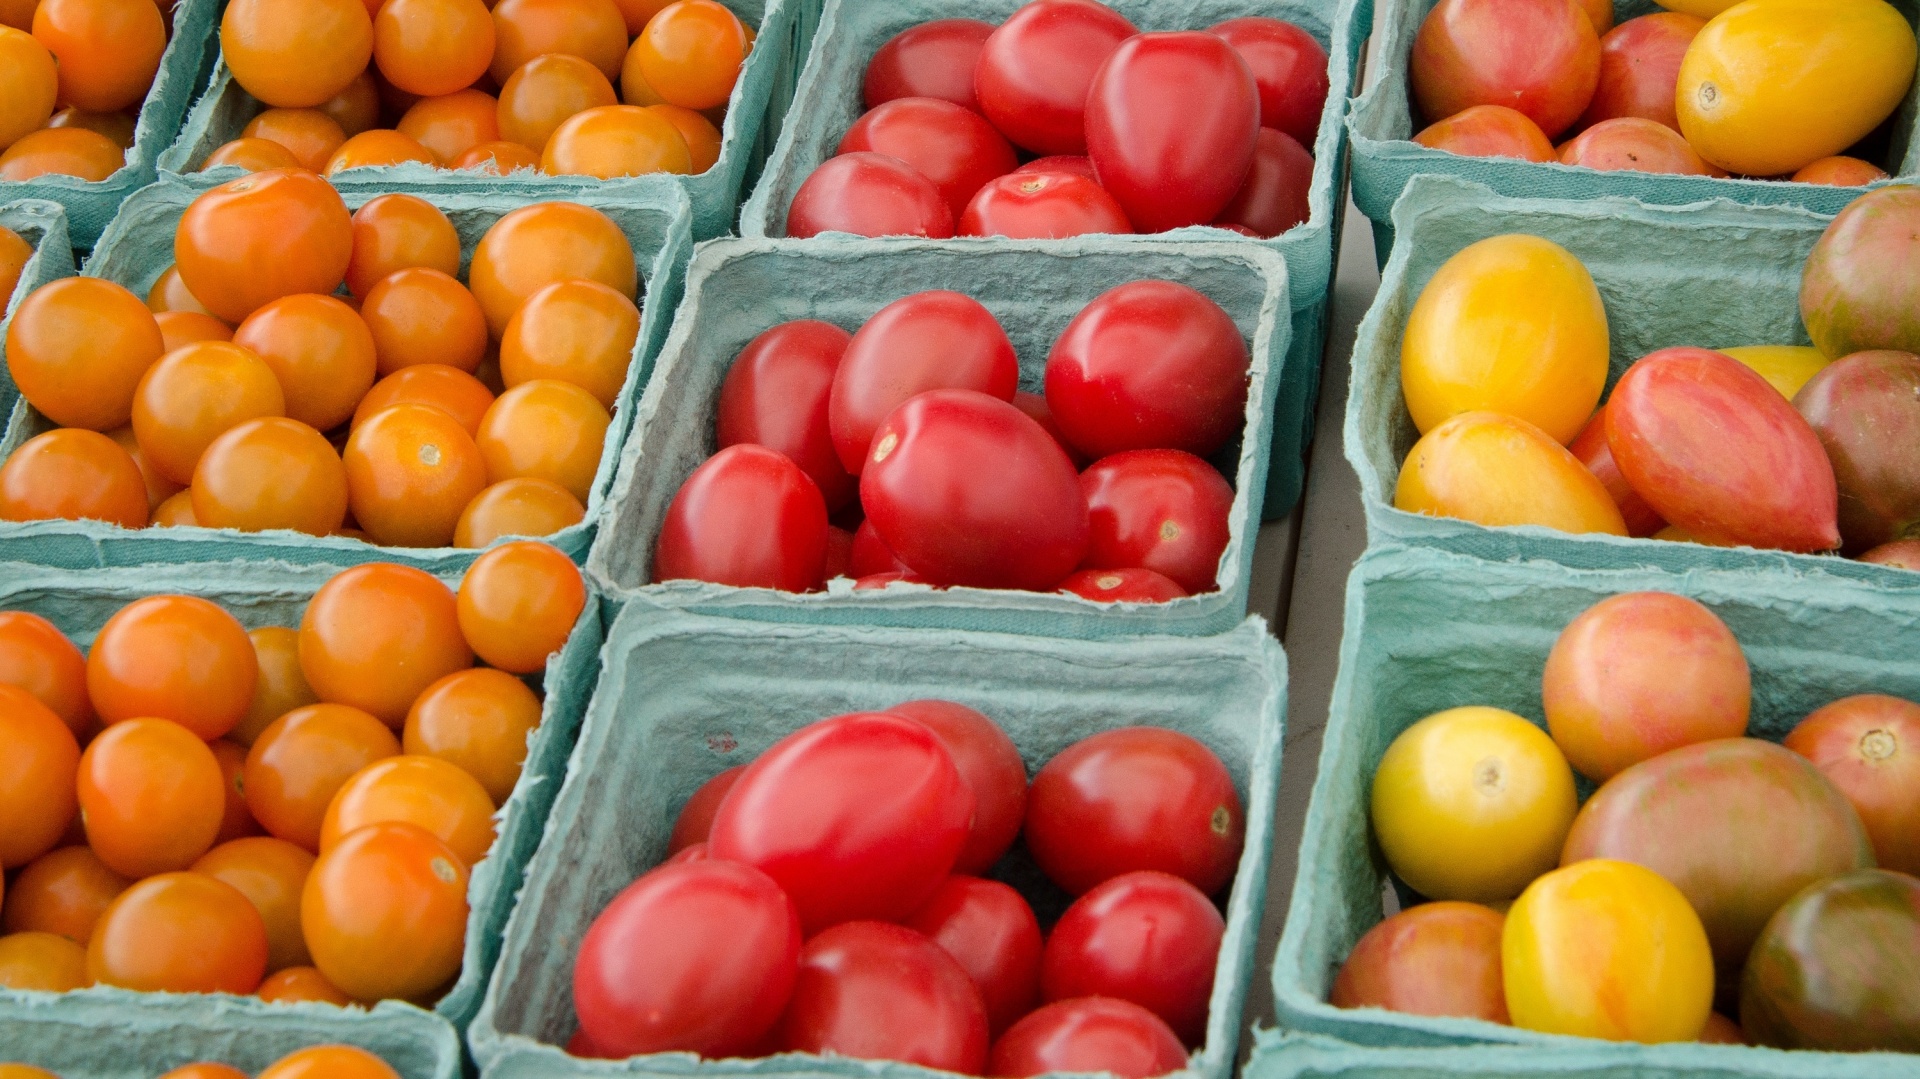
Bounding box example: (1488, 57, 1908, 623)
(173, 167, 365, 323)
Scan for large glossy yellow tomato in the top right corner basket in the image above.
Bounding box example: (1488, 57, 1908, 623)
(1674, 0, 1920, 177)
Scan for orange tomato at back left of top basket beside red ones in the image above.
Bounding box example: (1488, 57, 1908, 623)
(221, 0, 372, 107)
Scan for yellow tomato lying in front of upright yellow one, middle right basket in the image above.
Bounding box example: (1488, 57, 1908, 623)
(1394, 413, 1626, 536)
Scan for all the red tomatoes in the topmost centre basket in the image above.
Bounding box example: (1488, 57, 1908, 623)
(787, 0, 1327, 240)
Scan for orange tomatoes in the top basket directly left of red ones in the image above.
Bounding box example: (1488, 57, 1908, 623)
(202, 0, 755, 179)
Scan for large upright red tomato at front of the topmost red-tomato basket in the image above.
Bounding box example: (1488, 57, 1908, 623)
(1087, 33, 1260, 232)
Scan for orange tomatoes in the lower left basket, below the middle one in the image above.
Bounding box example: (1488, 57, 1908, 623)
(0, 541, 588, 1006)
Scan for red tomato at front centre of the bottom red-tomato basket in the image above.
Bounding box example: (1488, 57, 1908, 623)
(780, 922, 987, 1075)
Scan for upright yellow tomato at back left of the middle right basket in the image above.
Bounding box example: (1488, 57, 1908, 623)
(1400, 234, 1607, 445)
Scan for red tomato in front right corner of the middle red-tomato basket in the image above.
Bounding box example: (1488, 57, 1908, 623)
(1081, 449, 1233, 595)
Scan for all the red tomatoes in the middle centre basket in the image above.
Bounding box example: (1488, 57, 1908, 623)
(653, 280, 1250, 603)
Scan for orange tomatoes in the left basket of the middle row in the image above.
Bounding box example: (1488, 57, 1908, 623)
(0, 169, 639, 547)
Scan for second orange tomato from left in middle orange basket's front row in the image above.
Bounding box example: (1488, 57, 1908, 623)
(190, 417, 348, 536)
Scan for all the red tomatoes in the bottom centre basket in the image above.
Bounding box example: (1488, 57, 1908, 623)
(568, 701, 1246, 1079)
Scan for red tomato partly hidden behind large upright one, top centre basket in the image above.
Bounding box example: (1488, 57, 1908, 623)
(973, 0, 1140, 154)
